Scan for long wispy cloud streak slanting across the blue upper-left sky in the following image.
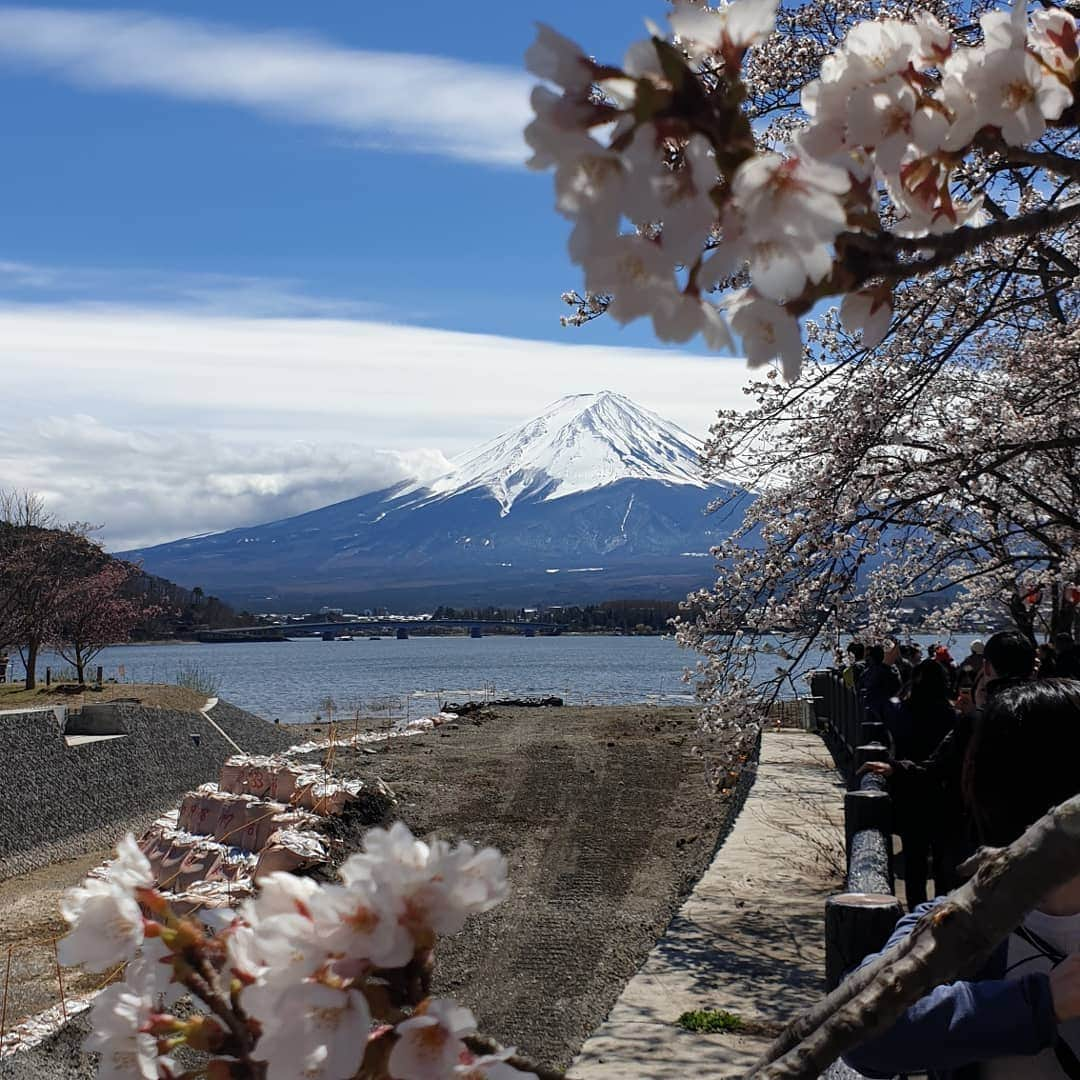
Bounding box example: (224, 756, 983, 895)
(0, 8, 530, 165)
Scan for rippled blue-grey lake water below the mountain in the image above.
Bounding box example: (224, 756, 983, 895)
(21, 634, 984, 724)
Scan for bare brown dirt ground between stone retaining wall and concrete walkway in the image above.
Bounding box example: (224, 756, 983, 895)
(0, 705, 747, 1076)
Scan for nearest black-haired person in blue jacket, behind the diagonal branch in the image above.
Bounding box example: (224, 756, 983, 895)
(845, 679, 1080, 1080)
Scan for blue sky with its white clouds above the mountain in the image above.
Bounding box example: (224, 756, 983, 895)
(0, 0, 743, 545)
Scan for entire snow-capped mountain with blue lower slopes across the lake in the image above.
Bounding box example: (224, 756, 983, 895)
(125, 391, 751, 611)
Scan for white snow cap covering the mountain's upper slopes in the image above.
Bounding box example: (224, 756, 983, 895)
(411, 390, 707, 516)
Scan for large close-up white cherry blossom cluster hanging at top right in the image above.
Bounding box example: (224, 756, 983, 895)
(530, 0, 1078, 380)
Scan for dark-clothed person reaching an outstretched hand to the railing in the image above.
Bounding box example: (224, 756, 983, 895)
(863, 630, 1035, 894)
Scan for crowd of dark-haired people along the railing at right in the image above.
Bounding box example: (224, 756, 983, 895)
(829, 631, 1080, 1080)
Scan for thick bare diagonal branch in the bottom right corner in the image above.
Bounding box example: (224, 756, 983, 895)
(747, 796, 1080, 1080)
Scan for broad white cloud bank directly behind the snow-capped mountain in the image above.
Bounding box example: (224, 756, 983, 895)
(0, 306, 746, 549)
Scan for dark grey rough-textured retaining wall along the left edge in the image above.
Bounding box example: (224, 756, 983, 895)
(0, 702, 292, 879)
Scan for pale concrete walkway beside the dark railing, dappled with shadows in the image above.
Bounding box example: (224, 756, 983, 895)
(567, 731, 843, 1080)
